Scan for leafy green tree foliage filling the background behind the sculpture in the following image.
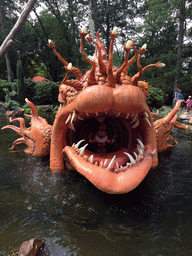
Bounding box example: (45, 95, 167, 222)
(0, 0, 192, 108)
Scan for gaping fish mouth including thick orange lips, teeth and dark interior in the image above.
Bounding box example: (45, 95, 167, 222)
(50, 85, 157, 193)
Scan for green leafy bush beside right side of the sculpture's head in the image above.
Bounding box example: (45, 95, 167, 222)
(147, 87, 166, 108)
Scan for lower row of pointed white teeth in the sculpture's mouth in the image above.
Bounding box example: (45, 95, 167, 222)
(72, 139, 145, 171)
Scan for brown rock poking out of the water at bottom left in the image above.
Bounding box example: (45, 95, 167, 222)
(18, 238, 45, 256)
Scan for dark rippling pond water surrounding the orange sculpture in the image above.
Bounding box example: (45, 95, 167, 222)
(0, 117, 192, 256)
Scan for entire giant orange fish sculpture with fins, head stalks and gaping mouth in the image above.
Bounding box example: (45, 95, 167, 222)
(2, 28, 187, 194)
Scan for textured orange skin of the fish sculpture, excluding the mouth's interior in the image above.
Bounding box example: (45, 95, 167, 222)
(4, 31, 187, 194)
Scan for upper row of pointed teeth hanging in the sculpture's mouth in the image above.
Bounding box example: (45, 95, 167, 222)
(65, 111, 151, 130)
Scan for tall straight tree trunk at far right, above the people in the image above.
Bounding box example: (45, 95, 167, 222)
(173, 1, 185, 92)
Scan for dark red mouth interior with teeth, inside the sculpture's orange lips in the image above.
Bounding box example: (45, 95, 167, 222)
(63, 110, 148, 172)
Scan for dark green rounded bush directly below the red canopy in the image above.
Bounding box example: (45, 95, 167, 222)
(35, 81, 59, 105)
